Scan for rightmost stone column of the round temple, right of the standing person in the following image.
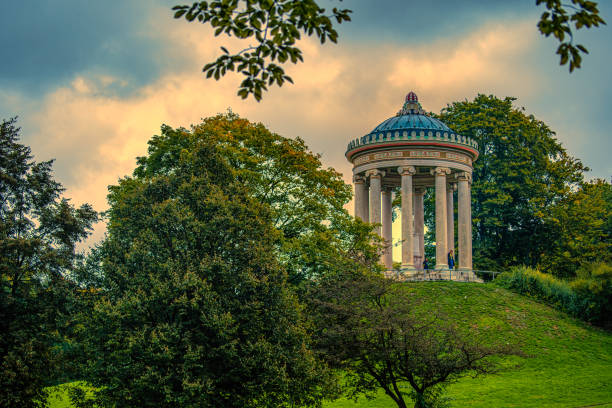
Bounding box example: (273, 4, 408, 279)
(457, 172, 472, 271)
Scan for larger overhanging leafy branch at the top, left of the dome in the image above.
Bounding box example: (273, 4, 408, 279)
(173, 0, 351, 101)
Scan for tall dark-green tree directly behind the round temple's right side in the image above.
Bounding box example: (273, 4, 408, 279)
(430, 95, 588, 270)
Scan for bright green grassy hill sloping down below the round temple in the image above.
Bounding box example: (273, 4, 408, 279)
(325, 282, 612, 408)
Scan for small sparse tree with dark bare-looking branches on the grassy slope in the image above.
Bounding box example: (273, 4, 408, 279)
(310, 273, 518, 408)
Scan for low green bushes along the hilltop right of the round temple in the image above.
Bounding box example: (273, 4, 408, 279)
(495, 264, 612, 327)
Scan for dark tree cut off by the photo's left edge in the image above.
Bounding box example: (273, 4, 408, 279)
(0, 119, 97, 407)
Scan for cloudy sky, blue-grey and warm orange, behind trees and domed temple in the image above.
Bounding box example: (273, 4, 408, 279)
(0, 0, 612, 252)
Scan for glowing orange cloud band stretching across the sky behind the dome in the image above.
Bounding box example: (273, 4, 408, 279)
(25, 16, 537, 252)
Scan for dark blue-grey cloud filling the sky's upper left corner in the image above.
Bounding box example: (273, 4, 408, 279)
(0, 0, 180, 96)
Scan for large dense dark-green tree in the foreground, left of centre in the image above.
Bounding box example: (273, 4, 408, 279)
(75, 118, 334, 407)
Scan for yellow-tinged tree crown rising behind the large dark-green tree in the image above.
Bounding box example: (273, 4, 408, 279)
(135, 114, 354, 284)
